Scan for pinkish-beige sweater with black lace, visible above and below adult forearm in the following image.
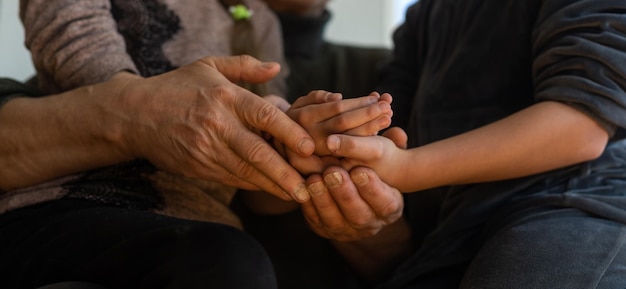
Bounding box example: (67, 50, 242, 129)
(0, 0, 286, 228)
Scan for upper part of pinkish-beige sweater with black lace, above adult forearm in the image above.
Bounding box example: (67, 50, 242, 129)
(20, 0, 286, 95)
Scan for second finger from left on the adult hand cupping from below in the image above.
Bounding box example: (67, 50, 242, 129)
(318, 167, 378, 230)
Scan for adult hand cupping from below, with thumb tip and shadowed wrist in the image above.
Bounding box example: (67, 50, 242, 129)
(301, 128, 414, 282)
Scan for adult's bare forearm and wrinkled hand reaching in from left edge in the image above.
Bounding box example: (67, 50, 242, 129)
(0, 56, 314, 202)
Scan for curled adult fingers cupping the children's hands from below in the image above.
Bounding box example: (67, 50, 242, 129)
(302, 167, 404, 241)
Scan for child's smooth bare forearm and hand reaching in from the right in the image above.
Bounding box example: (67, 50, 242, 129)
(328, 101, 608, 192)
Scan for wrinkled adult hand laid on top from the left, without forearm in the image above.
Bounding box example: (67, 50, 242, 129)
(118, 56, 314, 202)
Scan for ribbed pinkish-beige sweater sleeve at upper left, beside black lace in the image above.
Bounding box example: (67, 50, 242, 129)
(20, 0, 136, 93)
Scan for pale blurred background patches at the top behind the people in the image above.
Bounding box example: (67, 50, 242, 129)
(0, 0, 416, 80)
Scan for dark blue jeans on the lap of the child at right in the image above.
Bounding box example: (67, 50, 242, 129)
(381, 141, 626, 289)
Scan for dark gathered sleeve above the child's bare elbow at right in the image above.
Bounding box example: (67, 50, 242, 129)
(533, 0, 626, 138)
